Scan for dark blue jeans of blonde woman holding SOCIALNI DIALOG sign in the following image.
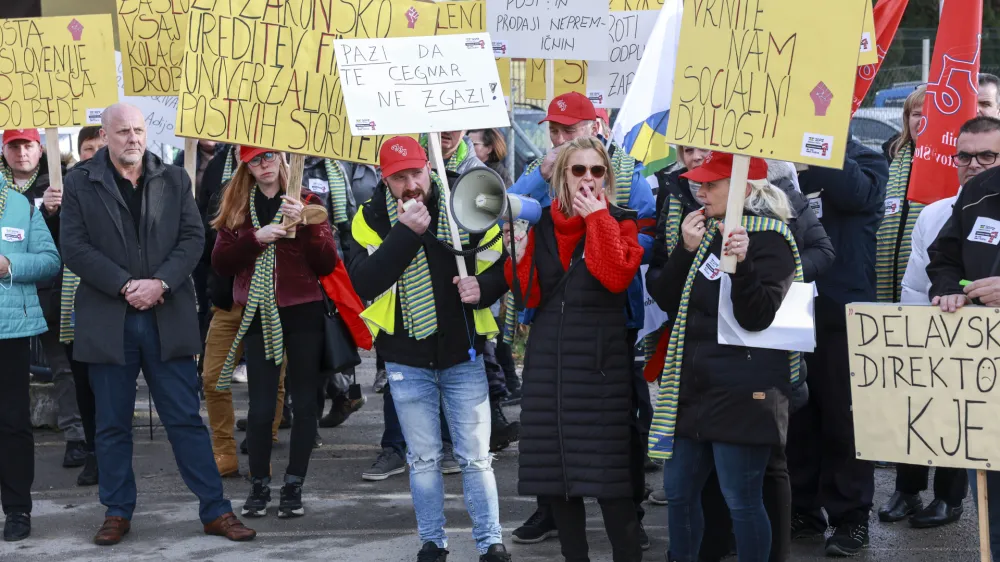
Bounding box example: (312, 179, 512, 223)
(663, 438, 771, 562)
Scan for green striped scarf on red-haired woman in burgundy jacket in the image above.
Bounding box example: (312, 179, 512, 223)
(215, 185, 285, 392)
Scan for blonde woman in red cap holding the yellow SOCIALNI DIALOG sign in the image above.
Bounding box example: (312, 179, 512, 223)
(648, 152, 802, 562)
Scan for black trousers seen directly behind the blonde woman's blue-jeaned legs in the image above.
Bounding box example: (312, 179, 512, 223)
(699, 446, 792, 562)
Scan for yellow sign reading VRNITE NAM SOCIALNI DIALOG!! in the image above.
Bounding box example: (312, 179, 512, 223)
(667, 0, 871, 168)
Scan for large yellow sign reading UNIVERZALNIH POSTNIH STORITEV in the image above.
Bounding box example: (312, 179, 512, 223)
(176, 0, 438, 163)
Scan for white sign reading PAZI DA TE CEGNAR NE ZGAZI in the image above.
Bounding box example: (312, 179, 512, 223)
(334, 33, 510, 135)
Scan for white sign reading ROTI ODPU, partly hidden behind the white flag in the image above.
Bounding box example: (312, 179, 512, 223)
(587, 11, 657, 107)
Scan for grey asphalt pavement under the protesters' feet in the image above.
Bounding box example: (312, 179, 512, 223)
(0, 357, 979, 562)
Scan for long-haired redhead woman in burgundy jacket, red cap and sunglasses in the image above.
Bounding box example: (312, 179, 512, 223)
(212, 146, 337, 518)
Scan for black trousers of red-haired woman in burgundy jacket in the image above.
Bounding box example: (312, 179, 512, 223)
(243, 332, 323, 478)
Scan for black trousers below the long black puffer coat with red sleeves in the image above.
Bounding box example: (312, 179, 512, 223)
(543, 496, 642, 562)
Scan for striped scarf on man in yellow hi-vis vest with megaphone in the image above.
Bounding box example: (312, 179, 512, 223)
(385, 172, 469, 340)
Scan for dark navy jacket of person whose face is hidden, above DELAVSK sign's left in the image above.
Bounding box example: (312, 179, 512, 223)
(799, 137, 889, 330)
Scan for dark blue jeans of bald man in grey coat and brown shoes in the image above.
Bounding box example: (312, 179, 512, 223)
(90, 310, 233, 523)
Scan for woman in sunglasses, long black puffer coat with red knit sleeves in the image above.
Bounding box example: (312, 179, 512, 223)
(505, 137, 643, 562)
